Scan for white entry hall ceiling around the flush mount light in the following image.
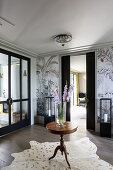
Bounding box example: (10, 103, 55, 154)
(0, 0, 113, 54)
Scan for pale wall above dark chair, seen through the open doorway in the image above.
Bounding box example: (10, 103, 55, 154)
(78, 73, 86, 93)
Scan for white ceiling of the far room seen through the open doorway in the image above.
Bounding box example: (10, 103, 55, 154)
(70, 55, 86, 73)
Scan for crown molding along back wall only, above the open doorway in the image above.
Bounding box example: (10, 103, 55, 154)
(38, 41, 113, 57)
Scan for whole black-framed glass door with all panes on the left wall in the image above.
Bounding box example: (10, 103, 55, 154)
(0, 50, 31, 135)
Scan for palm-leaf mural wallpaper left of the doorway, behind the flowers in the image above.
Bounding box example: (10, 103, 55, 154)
(36, 56, 59, 115)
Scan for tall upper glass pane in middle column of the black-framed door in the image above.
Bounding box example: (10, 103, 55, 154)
(11, 57, 20, 100)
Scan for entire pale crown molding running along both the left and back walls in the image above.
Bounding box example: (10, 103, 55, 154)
(0, 39, 113, 58)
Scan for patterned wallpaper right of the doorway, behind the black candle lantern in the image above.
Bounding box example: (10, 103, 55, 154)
(97, 48, 113, 133)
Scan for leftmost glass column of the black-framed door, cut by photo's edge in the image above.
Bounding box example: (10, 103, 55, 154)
(0, 53, 9, 128)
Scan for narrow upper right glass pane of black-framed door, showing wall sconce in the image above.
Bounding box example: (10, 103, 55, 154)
(22, 60, 28, 99)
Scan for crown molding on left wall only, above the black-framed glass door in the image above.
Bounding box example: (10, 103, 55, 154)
(0, 39, 37, 58)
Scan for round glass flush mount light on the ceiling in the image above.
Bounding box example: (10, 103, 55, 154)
(53, 34, 72, 46)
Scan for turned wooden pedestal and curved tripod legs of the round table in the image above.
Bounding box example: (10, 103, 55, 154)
(49, 135, 71, 169)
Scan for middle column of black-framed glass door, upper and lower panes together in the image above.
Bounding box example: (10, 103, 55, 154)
(11, 56, 20, 124)
